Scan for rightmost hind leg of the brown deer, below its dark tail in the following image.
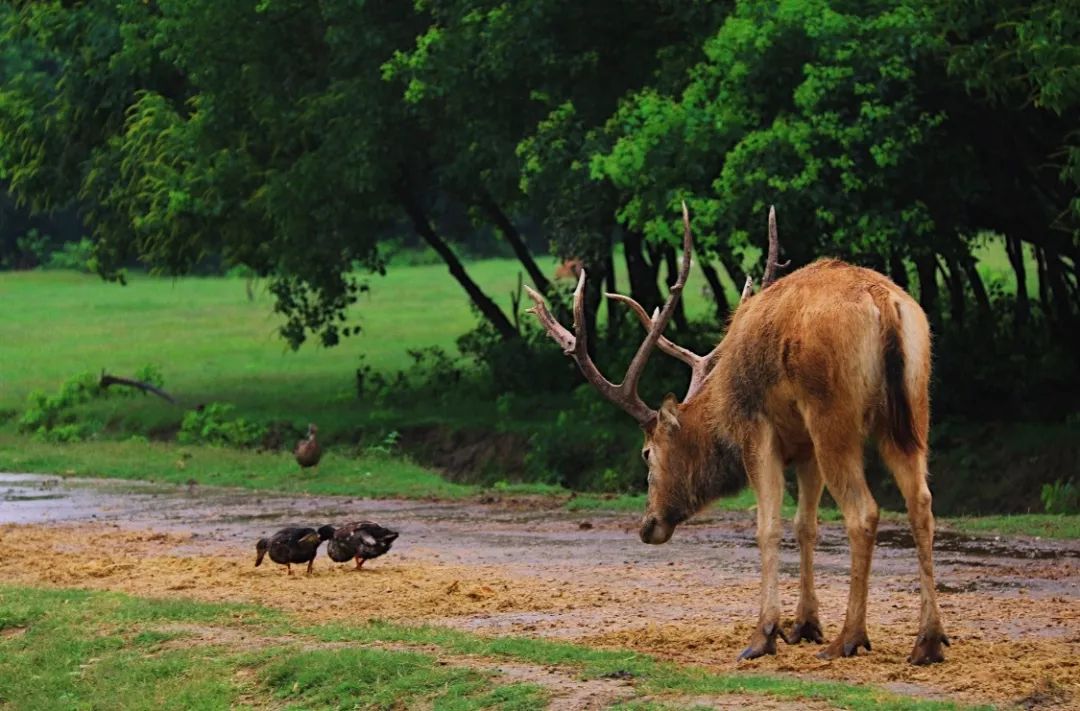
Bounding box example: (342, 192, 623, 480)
(880, 440, 948, 665)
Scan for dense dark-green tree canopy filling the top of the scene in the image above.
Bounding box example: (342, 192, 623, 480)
(0, 0, 1080, 391)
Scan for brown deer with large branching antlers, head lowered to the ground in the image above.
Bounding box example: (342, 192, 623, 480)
(529, 203, 948, 665)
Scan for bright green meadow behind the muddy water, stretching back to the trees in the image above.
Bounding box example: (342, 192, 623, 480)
(0, 245, 1078, 537)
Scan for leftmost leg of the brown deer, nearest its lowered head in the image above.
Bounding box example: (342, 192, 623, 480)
(739, 436, 784, 659)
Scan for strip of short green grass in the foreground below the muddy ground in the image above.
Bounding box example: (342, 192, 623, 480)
(0, 586, 989, 711)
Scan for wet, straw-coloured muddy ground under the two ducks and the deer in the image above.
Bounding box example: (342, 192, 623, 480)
(0, 474, 1080, 708)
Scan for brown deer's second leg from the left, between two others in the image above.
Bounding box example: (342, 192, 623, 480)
(784, 457, 825, 644)
